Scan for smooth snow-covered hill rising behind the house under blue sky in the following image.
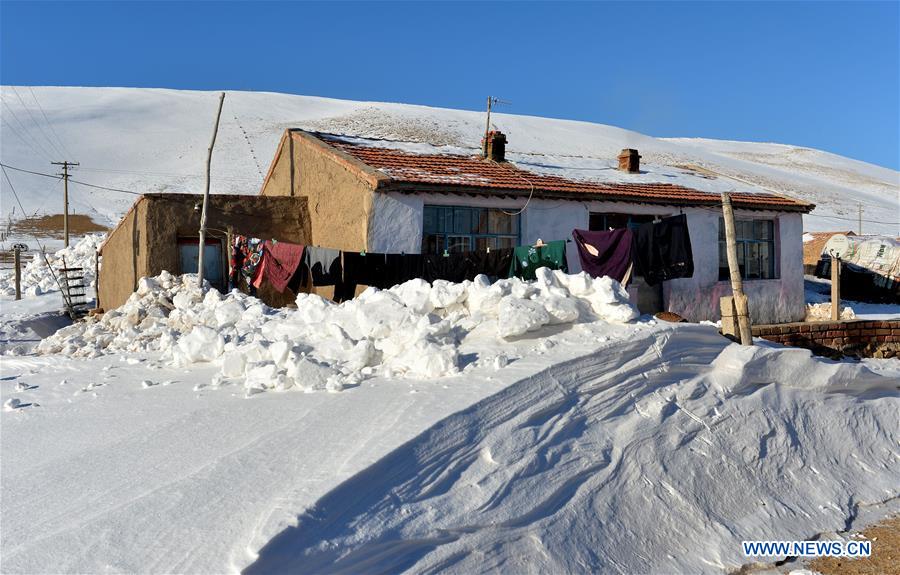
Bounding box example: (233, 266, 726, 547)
(0, 86, 900, 235)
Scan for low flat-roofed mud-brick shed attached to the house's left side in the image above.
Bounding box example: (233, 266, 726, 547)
(97, 194, 310, 309)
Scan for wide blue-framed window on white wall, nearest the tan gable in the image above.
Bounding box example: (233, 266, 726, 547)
(422, 206, 519, 254)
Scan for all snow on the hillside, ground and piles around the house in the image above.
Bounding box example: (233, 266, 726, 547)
(0, 87, 900, 573)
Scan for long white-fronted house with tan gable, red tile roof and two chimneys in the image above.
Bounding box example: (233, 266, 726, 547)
(261, 129, 814, 323)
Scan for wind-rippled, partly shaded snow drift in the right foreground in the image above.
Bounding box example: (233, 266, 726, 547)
(242, 325, 900, 575)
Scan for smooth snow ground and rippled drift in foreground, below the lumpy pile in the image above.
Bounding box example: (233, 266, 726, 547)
(0, 316, 900, 573)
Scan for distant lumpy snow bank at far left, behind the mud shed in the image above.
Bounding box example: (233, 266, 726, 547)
(0, 234, 106, 297)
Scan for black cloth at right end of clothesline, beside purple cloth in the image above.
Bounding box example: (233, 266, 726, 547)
(631, 214, 694, 285)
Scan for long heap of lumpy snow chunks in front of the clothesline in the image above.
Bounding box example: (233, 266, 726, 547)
(37, 268, 638, 394)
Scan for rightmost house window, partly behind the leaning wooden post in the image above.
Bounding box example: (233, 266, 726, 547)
(719, 218, 778, 280)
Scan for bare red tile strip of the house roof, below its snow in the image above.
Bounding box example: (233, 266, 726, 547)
(325, 138, 814, 212)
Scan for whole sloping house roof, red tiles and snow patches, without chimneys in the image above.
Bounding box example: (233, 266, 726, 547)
(318, 134, 813, 211)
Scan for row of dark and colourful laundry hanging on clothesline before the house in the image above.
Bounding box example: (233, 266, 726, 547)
(229, 214, 693, 301)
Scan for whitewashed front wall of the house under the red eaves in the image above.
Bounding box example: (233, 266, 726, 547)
(368, 192, 805, 323)
